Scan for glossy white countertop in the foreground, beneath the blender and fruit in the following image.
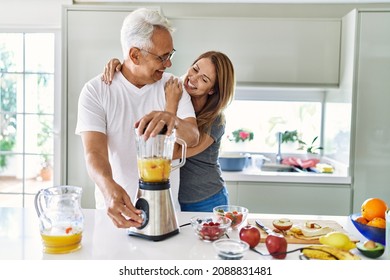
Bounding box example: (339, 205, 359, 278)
(0, 208, 383, 260)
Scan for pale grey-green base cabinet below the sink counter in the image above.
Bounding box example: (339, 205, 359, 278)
(227, 182, 352, 215)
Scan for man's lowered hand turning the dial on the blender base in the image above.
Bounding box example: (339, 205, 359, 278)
(104, 183, 143, 228)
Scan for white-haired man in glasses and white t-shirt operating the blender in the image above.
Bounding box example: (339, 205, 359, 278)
(76, 8, 199, 228)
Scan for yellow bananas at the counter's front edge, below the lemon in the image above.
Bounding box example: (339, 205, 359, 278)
(301, 245, 360, 260)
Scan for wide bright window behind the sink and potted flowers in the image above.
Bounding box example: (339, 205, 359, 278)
(222, 89, 324, 154)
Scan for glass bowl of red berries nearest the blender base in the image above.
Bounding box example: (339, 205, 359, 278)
(191, 216, 231, 241)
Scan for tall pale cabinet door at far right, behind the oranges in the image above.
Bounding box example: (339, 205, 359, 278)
(353, 11, 390, 212)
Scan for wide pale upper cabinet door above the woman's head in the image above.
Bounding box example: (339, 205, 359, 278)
(171, 18, 341, 85)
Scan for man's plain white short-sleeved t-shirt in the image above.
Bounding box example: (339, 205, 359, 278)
(76, 73, 195, 210)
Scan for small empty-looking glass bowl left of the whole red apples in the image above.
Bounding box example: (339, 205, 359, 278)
(213, 239, 249, 260)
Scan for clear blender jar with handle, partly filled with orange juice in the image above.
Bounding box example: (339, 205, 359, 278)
(135, 130, 187, 183)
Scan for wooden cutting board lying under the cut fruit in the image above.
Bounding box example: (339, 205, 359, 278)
(248, 219, 359, 244)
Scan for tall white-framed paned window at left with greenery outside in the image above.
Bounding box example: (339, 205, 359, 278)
(0, 32, 56, 207)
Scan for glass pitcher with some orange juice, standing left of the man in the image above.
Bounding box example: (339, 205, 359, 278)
(34, 186, 84, 254)
